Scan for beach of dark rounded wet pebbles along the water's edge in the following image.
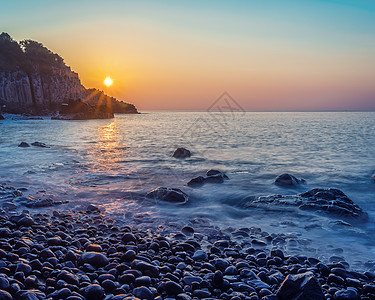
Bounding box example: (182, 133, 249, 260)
(0, 196, 375, 300)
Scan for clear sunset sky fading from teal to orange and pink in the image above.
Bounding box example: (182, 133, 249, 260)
(0, 0, 375, 111)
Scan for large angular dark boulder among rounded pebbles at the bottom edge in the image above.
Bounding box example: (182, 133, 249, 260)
(276, 272, 325, 300)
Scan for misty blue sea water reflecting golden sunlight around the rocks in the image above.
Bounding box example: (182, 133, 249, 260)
(0, 112, 375, 270)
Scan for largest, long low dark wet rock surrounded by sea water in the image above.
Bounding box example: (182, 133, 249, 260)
(239, 189, 368, 221)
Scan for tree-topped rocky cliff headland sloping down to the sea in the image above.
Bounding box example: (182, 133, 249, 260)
(0, 32, 138, 119)
